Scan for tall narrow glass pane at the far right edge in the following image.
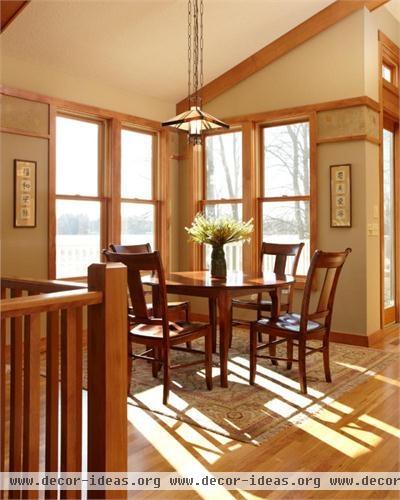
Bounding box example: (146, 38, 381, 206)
(383, 130, 396, 307)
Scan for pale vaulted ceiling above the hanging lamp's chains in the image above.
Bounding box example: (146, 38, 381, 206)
(1, 0, 399, 102)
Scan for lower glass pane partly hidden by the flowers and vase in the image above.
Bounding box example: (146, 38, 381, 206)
(204, 203, 243, 271)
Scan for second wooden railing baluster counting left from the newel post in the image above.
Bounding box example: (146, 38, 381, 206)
(46, 311, 60, 480)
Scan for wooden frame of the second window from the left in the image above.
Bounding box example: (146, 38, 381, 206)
(117, 124, 162, 250)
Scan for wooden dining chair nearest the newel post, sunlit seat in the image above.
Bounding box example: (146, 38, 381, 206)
(105, 251, 212, 404)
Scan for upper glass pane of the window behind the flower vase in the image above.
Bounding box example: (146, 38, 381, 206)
(206, 132, 242, 200)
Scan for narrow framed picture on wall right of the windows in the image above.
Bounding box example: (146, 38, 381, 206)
(330, 163, 352, 227)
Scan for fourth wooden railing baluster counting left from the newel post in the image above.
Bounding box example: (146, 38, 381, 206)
(9, 290, 23, 476)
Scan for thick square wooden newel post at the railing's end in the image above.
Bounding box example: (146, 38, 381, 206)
(88, 263, 128, 498)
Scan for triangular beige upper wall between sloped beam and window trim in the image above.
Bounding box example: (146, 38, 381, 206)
(205, 10, 364, 117)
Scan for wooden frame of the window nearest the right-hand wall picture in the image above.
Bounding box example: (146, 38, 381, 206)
(257, 112, 318, 280)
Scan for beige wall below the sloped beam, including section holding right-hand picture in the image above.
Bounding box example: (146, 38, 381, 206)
(180, 4, 400, 335)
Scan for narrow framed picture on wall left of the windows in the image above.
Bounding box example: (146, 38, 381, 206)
(14, 160, 37, 228)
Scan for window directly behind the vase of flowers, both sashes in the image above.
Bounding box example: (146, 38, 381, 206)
(202, 132, 243, 271)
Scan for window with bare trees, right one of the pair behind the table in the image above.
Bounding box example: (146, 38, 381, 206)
(260, 122, 311, 275)
